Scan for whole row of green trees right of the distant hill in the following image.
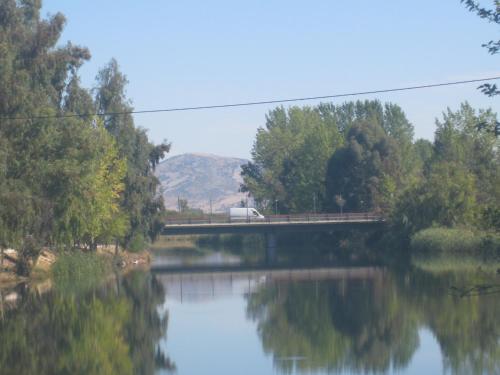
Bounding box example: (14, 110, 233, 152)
(242, 101, 500, 247)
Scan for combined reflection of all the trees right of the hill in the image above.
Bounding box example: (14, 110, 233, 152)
(247, 272, 500, 374)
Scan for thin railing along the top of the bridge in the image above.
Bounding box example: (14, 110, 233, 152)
(165, 212, 384, 225)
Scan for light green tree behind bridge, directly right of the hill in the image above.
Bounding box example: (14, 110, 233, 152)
(242, 107, 342, 212)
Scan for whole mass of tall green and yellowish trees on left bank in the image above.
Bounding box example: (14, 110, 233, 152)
(0, 0, 169, 272)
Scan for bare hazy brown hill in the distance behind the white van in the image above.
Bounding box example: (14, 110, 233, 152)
(156, 154, 248, 212)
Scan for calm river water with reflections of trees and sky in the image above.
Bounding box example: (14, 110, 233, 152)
(0, 242, 500, 374)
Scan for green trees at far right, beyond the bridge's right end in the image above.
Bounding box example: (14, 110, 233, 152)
(393, 103, 500, 238)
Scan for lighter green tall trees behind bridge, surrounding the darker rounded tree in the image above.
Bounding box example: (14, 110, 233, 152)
(242, 101, 413, 212)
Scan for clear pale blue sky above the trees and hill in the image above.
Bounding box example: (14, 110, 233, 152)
(43, 0, 500, 158)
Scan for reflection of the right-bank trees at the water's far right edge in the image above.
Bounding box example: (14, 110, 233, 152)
(402, 271, 500, 374)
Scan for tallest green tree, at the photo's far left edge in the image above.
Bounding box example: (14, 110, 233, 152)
(0, 0, 90, 262)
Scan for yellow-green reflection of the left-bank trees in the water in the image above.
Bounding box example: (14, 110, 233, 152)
(0, 273, 175, 374)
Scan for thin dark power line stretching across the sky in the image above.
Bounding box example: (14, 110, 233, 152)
(0, 76, 500, 120)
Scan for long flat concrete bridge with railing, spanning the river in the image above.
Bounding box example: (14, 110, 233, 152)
(162, 213, 385, 235)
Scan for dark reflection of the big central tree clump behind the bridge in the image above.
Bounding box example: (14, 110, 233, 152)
(247, 279, 418, 372)
